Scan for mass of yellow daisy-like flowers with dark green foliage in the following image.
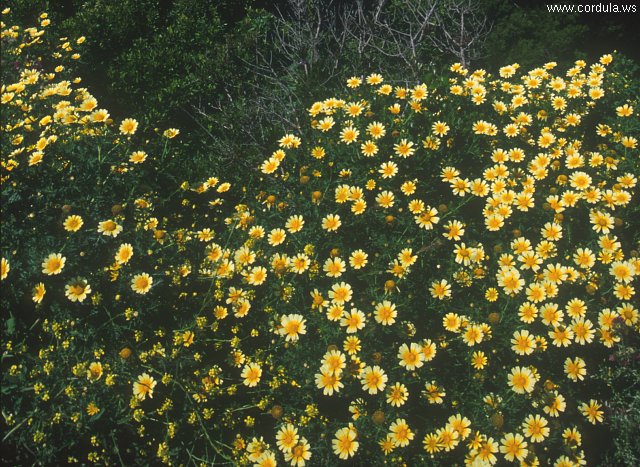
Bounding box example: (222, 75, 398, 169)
(2, 8, 640, 466)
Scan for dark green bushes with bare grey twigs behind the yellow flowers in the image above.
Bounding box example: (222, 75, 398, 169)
(11, 0, 638, 183)
